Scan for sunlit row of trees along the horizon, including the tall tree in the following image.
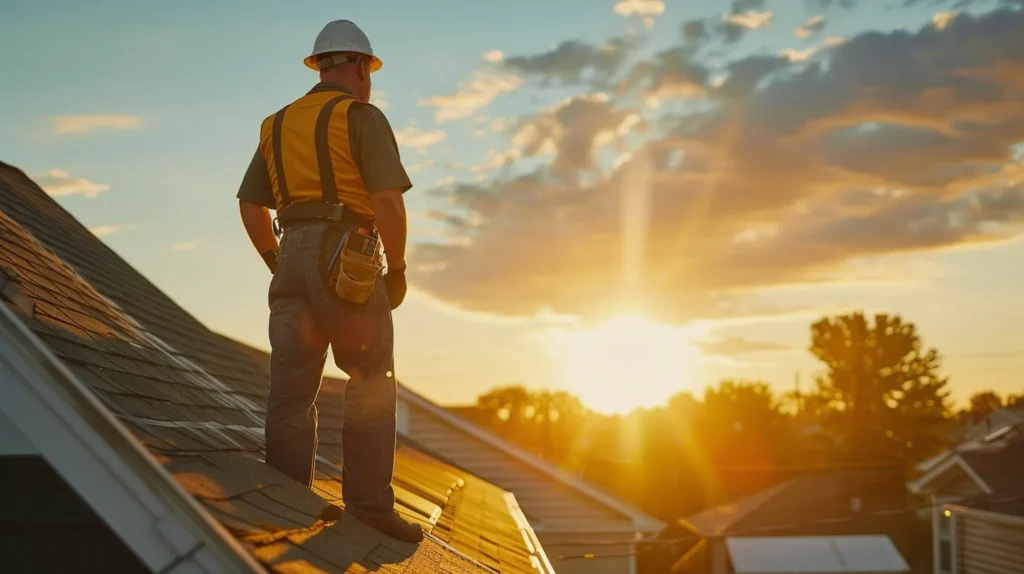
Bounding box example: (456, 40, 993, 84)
(455, 312, 1024, 520)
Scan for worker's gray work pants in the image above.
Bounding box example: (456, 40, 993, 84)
(265, 217, 397, 516)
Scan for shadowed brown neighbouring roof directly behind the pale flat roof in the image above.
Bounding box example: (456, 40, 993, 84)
(680, 468, 906, 536)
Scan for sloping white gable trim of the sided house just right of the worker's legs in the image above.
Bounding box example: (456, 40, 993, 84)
(398, 385, 666, 532)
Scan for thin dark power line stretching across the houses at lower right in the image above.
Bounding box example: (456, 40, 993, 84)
(545, 494, 1024, 560)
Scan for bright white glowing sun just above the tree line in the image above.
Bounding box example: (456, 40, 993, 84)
(549, 315, 700, 414)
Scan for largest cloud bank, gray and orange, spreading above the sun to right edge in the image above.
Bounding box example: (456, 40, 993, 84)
(410, 10, 1024, 322)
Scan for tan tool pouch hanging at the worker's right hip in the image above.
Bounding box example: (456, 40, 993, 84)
(328, 229, 384, 305)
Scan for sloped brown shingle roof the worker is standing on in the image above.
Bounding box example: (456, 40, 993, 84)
(0, 163, 544, 573)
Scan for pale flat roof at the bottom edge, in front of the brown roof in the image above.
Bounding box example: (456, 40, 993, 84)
(725, 535, 910, 574)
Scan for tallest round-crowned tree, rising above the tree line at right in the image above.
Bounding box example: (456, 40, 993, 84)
(810, 312, 949, 462)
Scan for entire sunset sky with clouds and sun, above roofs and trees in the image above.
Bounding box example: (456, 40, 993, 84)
(0, 0, 1024, 410)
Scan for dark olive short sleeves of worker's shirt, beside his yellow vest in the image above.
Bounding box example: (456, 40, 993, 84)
(236, 84, 413, 210)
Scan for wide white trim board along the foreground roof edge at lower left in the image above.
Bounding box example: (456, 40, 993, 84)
(0, 304, 265, 572)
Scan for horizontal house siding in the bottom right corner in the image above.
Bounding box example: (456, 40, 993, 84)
(954, 515, 1024, 574)
